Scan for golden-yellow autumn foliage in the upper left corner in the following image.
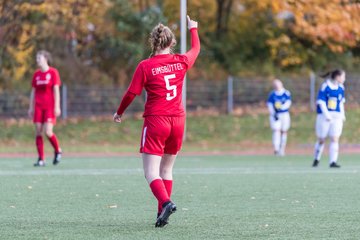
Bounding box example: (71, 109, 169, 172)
(0, 0, 111, 88)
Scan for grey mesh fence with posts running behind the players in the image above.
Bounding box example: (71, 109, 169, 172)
(0, 75, 360, 118)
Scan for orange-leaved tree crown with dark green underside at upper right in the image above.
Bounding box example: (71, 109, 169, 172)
(268, 0, 360, 69)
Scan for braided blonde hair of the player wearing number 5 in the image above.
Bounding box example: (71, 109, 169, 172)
(149, 23, 176, 57)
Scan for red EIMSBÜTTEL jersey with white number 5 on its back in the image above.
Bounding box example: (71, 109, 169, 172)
(128, 54, 188, 117)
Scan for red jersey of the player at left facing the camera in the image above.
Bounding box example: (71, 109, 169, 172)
(32, 67, 61, 109)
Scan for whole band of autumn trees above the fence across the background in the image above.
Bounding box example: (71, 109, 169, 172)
(0, 0, 360, 89)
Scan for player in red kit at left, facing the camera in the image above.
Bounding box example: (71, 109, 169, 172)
(28, 50, 61, 167)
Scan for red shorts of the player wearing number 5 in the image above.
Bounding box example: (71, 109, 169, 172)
(140, 116, 185, 156)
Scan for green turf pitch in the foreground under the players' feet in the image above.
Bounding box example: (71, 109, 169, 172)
(0, 155, 360, 240)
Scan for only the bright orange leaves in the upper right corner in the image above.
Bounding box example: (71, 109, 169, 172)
(272, 0, 360, 52)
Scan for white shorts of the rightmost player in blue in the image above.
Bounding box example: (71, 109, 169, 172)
(315, 114, 344, 138)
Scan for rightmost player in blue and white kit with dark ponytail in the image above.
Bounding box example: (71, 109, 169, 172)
(313, 69, 345, 168)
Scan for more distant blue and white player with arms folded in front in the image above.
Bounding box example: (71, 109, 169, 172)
(267, 79, 291, 156)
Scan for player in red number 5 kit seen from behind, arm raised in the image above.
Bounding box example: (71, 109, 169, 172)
(114, 16, 200, 227)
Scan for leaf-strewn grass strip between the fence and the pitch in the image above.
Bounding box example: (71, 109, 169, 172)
(0, 109, 360, 153)
